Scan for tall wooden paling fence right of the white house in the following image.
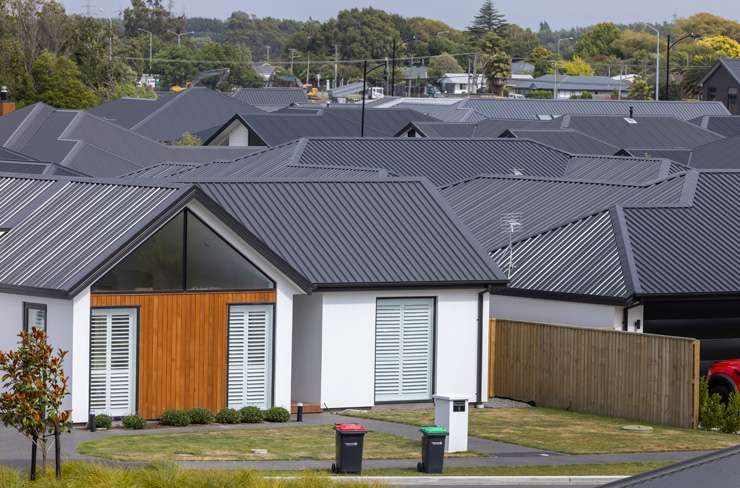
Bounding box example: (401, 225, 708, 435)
(488, 320, 699, 428)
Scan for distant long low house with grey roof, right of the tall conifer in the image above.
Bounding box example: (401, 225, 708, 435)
(507, 75, 631, 99)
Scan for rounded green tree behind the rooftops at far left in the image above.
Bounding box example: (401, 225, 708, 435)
(31, 52, 99, 108)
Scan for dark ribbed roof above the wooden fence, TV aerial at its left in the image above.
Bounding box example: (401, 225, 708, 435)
(493, 171, 740, 300)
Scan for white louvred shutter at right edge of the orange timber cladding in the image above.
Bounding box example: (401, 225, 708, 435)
(228, 305, 273, 408)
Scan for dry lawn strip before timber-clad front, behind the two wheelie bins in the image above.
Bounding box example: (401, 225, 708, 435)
(78, 425, 474, 462)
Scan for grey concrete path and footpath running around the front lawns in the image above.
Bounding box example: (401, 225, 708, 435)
(0, 413, 716, 470)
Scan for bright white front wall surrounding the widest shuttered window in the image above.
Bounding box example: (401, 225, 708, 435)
(321, 289, 488, 408)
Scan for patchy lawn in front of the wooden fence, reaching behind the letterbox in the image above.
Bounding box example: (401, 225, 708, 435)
(343, 407, 740, 454)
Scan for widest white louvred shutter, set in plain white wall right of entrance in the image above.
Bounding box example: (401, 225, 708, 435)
(375, 298, 434, 402)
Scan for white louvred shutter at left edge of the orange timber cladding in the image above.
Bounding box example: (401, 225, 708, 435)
(90, 309, 136, 417)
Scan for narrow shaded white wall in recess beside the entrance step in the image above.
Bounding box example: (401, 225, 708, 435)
(291, 294, 323, 403)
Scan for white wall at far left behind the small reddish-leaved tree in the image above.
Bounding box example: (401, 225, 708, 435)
(0, 293, 74, 409)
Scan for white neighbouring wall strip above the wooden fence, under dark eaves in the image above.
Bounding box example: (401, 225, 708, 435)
(490, 295, 623, 330)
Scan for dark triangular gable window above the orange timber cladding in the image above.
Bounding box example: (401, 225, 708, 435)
(92, 210, 275, 292)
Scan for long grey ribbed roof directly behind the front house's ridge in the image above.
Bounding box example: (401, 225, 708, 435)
(163, 137, 684, 186)
